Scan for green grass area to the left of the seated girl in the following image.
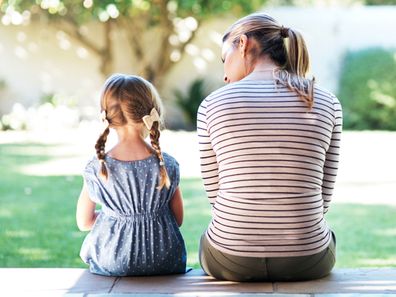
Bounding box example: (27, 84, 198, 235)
(0, 143, 84, 267)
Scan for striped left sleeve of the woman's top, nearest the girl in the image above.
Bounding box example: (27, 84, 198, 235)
(197, 100, 219, 205)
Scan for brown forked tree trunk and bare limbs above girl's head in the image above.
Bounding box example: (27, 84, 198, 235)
(53, 6, 197, 89)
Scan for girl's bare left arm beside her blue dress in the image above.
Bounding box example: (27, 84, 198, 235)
(76, 182, 99, 231)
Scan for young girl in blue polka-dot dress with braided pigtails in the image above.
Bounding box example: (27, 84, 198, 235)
(76, 74, 186, 276)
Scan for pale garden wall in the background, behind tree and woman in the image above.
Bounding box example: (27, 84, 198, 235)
(0, 6, 396, 122)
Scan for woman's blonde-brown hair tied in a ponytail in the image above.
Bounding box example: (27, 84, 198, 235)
(223, 13, 315, 108)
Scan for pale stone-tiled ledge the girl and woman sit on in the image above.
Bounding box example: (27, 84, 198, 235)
(0, 268, 396, 297)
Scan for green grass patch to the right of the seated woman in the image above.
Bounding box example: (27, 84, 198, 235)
(327, 203, 396, 268)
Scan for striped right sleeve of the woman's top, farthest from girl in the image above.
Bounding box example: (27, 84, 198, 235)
(322, 97, 342, 213)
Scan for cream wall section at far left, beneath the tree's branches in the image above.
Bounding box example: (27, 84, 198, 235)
(0, 24, 101, 114)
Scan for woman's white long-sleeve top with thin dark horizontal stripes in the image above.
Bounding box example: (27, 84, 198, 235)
(197, 80, 342, 257)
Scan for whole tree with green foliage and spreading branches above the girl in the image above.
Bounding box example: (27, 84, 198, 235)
(0, 0, 266, 86)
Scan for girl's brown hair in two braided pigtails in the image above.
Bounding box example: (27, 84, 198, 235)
(95, 74, 170, 189)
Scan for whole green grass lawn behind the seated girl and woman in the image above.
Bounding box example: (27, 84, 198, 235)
(0, 143, 396, 267)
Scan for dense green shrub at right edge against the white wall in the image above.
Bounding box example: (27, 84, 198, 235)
(338, 48, 396, 130)
